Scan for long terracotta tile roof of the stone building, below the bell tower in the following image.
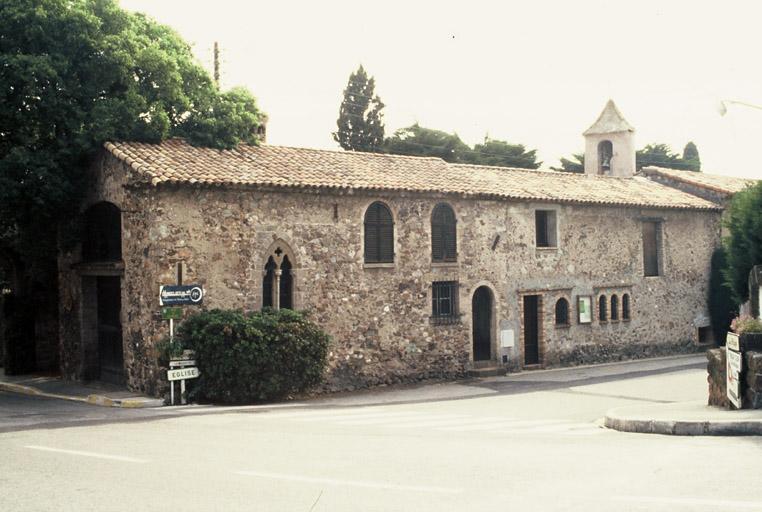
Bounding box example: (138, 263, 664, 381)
(105, 139, 719, 210)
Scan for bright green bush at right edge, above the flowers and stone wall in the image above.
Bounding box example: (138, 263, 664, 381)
(723, 182, 762, 305)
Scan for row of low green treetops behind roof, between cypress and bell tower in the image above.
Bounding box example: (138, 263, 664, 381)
(383, 123, 541, 169)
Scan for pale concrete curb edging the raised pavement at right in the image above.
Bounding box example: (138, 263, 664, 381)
(603, 409, 762, 436)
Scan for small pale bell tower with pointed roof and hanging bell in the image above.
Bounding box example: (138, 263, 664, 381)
(583, 100, 635, 178)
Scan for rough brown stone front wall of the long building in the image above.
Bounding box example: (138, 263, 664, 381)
(62, 157, 719, 392)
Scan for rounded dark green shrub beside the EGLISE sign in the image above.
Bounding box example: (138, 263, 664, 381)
(178, 309, 330, 403)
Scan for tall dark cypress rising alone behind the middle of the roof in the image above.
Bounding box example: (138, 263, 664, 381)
(333, 66, 384, 152)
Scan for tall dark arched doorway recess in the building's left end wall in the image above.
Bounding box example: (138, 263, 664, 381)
(81, 202, 124, 384)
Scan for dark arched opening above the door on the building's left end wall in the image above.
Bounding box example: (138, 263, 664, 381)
(82, 202, 122, 261)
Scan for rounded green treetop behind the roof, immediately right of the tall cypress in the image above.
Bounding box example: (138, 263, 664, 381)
(384, 123, 471, 162)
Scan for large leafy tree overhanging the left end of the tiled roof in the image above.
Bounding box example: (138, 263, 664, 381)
(0, 0, 261, 264)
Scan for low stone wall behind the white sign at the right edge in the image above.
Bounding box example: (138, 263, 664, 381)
(706, 347, 762, 409)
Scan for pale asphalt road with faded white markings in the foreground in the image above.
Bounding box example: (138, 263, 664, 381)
(0, 356, 762, 511)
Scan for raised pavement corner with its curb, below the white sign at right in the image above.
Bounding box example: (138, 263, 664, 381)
(604, 400, 762, 436)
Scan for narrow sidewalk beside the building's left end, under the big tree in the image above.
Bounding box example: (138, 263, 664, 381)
(0, 368, 164, 409)
